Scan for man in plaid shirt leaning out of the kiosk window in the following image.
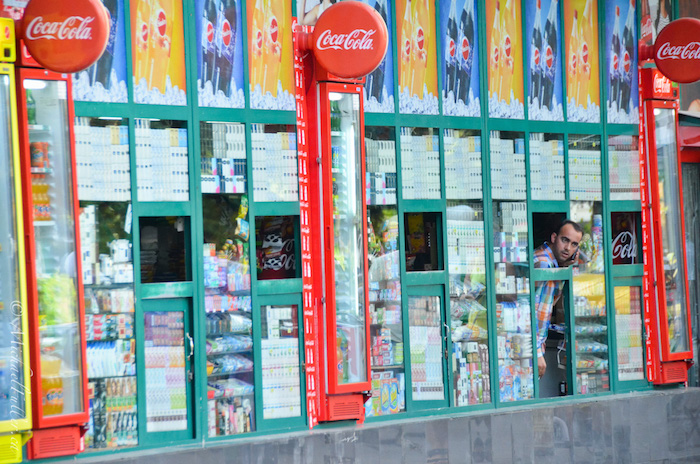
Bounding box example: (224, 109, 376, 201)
(535, 220, 583, 377)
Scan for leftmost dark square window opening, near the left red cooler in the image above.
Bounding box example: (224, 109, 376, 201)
(139, 216, 191, 284)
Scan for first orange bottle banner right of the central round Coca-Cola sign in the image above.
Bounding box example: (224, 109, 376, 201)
(396, 0, 439, 114)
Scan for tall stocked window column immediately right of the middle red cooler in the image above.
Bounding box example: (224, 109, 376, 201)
(365, 127, 406, 417)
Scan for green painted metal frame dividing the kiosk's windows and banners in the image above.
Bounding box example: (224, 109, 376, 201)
(69, 0, 650, 456)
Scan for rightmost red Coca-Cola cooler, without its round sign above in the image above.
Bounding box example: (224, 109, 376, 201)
(639, 67, 693, 384)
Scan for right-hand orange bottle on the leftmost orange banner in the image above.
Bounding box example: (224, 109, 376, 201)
(148, 0, 174, 93)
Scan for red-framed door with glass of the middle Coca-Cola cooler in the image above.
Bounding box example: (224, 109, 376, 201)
(320, 84, 370, 395)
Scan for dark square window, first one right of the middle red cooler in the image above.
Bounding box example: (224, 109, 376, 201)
(404, 213, 443, 272)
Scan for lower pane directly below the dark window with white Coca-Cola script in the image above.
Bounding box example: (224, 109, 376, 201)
(616, 287, 645, 381)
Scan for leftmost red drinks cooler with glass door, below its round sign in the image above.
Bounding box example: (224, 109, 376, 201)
(17, 47, 93, 459)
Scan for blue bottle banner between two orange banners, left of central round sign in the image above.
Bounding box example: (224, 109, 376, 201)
(195, 0, 245, 108)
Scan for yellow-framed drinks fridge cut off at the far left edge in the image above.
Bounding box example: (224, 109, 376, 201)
(0, 18, 32, 464)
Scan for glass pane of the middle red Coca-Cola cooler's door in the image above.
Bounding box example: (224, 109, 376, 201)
(326, 91, 369, 393)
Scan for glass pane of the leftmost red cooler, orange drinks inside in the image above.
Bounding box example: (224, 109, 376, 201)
(22, 79, 85, 424)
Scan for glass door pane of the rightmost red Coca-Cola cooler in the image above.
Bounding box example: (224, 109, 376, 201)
(650, 108, 692, 360)
